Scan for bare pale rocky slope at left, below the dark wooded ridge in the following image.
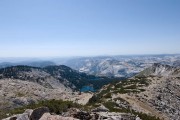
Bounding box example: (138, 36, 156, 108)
(0, 79, 72, 110)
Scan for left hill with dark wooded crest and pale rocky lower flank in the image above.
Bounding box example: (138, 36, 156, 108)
(0, 66, 72, 110)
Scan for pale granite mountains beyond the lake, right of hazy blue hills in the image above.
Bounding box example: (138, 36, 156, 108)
(64, 55, 180, 77)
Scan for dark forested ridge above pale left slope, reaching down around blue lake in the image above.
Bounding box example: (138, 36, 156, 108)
(0, 65, 124, 92)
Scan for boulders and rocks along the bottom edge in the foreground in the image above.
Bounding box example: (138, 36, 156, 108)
(3, 106, 141, 120)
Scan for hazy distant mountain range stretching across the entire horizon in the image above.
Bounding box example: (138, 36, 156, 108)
(0, 54, 180, 77)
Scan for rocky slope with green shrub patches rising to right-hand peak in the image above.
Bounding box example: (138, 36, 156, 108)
(90, 64, 180, 120)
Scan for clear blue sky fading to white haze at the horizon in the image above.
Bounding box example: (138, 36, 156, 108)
(0, 0, 180, 57)
